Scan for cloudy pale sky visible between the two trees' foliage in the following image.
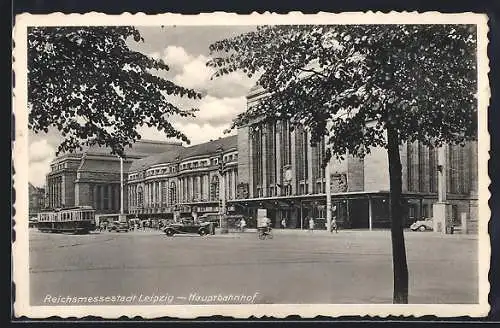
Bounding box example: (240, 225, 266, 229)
(29, 26, 255, 187)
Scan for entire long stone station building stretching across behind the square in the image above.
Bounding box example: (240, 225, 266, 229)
(41, 88, 478, 233)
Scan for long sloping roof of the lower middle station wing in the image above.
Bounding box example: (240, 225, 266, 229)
(129, 135, 238, 172)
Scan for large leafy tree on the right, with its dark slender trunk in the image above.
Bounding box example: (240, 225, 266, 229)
(207, 25, 477, 303)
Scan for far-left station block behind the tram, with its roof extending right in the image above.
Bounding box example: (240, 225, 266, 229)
(45, 141, 181, 214)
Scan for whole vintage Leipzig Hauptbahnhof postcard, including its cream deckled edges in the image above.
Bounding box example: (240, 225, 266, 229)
(12, 12, 490, 318)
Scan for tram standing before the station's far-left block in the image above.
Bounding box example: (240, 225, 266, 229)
(37, 206, 96, 234)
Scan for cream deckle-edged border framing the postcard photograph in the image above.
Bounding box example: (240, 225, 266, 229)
(12, 12, 491, 318)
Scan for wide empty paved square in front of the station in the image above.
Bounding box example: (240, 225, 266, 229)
(30, 230, 478, 305)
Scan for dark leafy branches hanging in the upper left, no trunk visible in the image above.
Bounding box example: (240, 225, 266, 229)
(28, 26, 201, 155)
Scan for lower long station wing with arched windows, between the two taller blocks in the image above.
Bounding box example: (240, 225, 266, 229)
(127, 136, 238, 219)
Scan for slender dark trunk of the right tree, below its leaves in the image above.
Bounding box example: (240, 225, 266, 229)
(387, 126, 408, 304)
